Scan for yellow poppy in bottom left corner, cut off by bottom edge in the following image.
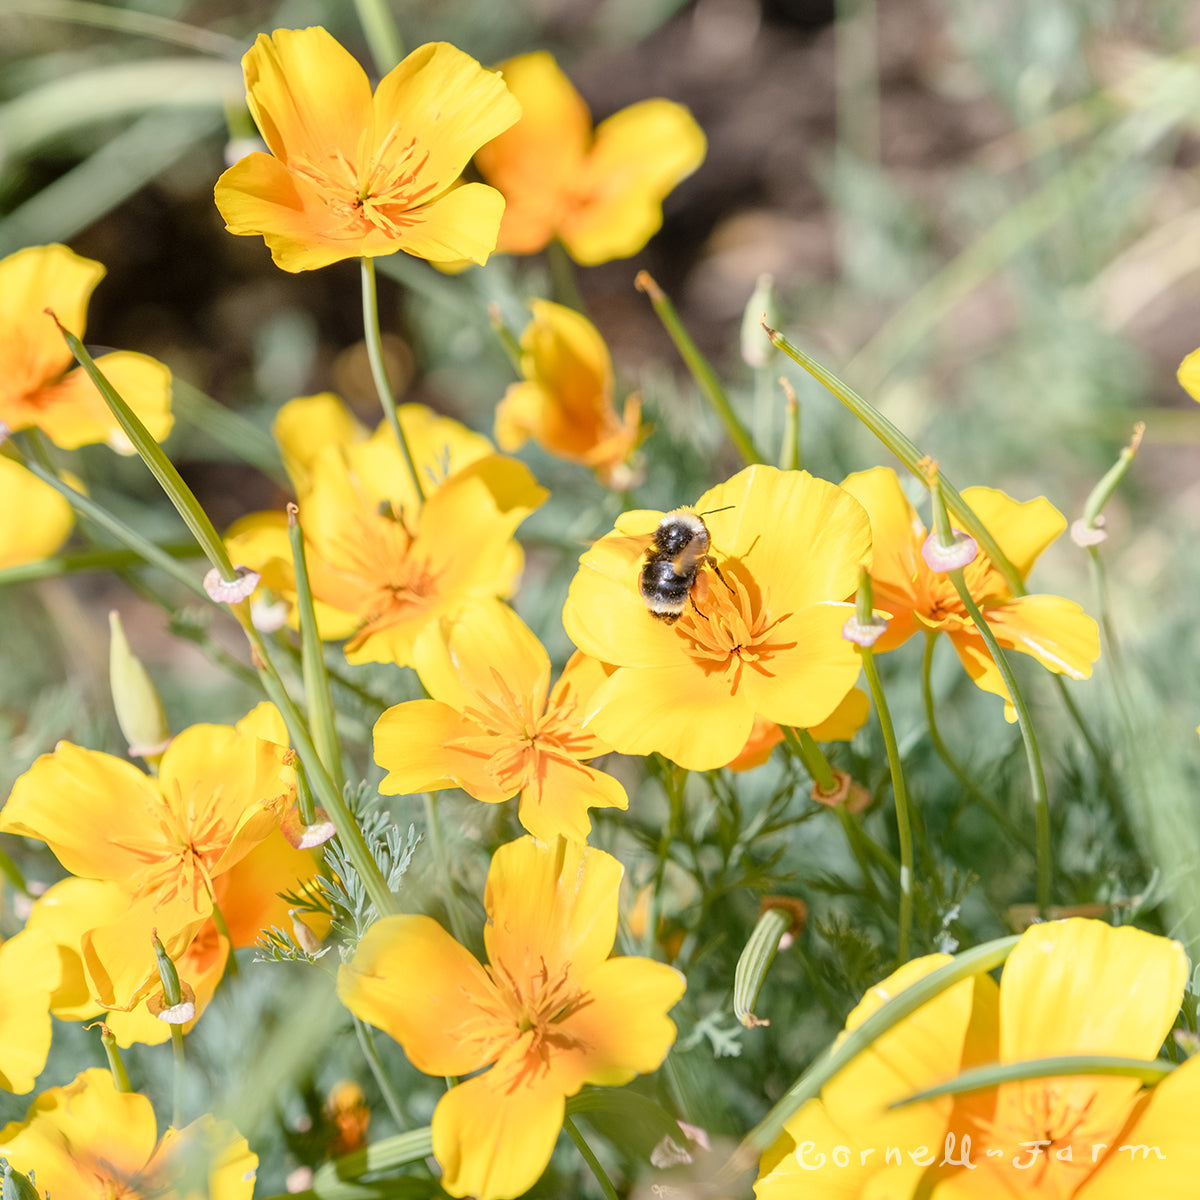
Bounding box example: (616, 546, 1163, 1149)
(0, 1068, 258, 1200)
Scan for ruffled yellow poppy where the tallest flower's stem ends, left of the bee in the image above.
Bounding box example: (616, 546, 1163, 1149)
(226, 397, 548, 665)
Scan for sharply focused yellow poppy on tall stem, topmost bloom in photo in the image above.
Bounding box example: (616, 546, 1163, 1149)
(216, 28, 521, 271)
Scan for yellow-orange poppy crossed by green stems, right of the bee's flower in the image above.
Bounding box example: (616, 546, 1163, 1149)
(841, 467, 1100, 721)
